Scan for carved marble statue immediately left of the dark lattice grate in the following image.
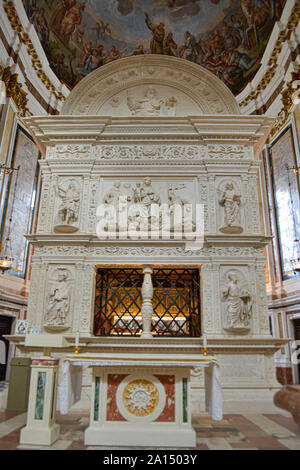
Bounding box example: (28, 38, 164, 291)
(45, 269, 71, 330)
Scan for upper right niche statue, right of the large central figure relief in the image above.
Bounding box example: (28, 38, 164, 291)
(219, 183, 243, 233)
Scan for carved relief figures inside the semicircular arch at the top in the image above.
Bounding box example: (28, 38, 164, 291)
(127, 86, 177, 116)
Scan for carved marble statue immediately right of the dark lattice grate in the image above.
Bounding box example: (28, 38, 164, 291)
(222, 272, 252, 332)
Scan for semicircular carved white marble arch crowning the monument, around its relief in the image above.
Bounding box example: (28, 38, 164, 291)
(62, 55, 240, 116)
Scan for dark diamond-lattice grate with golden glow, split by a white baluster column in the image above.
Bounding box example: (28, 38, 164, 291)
(94, 267, 201, 337)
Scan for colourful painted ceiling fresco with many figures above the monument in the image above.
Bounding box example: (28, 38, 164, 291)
(23, 0, 285, 94)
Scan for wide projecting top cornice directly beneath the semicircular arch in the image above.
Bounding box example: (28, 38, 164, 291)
(25, 115, 273, 151)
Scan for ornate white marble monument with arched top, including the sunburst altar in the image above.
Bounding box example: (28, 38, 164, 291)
(14, 55, 281, 446)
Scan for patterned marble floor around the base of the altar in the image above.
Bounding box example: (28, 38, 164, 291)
(0, 409, 300, 451)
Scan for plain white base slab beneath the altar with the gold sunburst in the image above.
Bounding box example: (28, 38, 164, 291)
(84, 423, 196, 447)
